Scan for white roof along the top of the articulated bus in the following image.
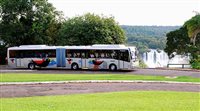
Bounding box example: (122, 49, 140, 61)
(8, 44, 131, 50)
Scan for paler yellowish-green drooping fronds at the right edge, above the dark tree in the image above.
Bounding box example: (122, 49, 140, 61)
(184, 14, 200, 45)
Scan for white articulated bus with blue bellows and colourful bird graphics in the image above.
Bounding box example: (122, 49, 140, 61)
(7, 44, 137, 71)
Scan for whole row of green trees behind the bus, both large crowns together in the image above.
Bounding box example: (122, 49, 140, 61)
(0, 0, 126, 62)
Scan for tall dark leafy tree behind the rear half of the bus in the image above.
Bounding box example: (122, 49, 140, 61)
(0, 0, 61, 46)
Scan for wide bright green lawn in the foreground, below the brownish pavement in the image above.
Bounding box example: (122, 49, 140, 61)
(0, 91, 200, 111)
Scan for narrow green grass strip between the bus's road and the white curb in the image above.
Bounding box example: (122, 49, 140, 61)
(0, 73, 200, 82)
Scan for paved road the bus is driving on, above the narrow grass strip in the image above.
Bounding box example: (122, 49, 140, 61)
(0, 67, 200, 78)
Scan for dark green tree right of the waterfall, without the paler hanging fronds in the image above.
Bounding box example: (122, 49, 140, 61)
(165, 26, 200, 69)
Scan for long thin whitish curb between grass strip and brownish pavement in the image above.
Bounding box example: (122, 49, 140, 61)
(0, 80, 200, 85)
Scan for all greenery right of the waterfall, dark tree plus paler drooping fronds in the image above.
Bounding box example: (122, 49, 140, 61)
(165, 14, 200, 69)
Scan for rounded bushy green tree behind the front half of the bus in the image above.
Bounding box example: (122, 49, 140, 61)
(59, 13, 125, 45)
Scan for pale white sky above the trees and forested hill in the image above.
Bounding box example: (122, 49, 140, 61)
(49, 0, 200, 26)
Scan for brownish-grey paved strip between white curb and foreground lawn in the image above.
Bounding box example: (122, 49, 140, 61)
(0, 83, 200, 98)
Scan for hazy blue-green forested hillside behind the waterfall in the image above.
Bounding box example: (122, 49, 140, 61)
(121, 25, 180, 53)
